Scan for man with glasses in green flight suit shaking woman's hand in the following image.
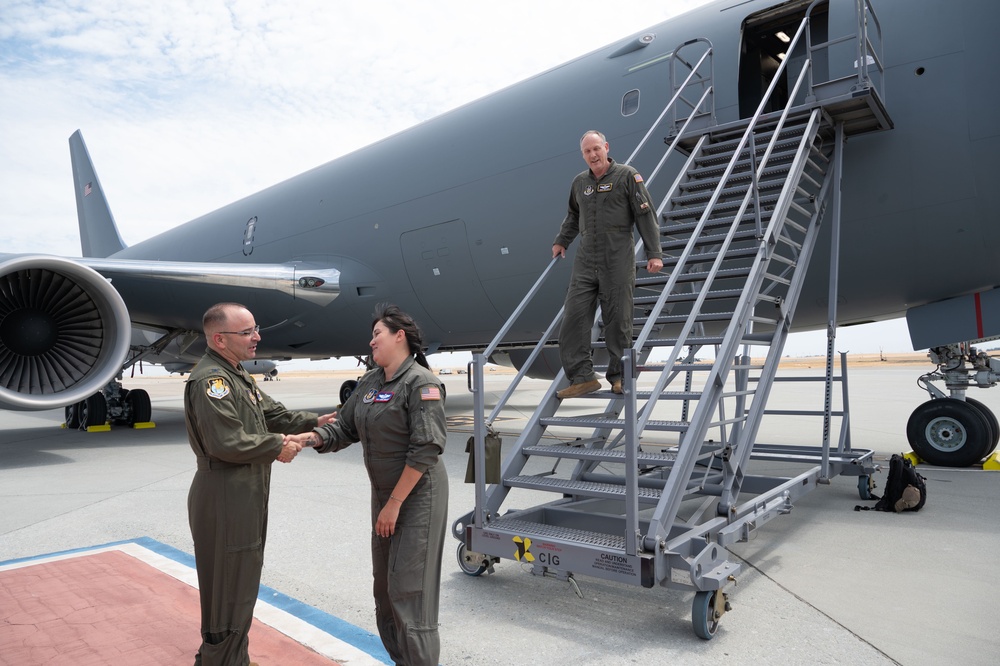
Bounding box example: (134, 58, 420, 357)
(184, 303, 334, 666)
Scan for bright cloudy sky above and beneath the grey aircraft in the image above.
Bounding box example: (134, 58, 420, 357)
(0, 0, 908, 355)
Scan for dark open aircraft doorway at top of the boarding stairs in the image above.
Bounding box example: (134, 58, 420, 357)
(739, 0, 829, 118)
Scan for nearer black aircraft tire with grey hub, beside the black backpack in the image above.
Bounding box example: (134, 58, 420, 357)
(906, 398, 992, 467)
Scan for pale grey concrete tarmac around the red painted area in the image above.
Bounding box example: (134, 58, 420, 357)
(0, 366, 1000, 666)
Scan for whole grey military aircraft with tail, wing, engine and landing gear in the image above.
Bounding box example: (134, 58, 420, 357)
(0, 0, 1000, 464)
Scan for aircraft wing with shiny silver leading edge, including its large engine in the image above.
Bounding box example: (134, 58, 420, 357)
(0, 254, 340, 410)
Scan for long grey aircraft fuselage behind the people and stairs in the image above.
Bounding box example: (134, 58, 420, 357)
(11, 0, 1000, 368)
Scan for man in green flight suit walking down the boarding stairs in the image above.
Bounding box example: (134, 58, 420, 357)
(552, 130, 663, 399)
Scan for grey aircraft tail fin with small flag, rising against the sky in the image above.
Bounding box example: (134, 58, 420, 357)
(69, 130, 126, 258)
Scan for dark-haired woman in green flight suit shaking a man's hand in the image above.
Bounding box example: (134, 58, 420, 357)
(300, 305, 448, 666)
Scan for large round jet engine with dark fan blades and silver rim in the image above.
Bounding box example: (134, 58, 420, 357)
(0, 255, 132, 411)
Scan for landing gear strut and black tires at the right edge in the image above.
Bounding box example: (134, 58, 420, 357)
(906, 343, 1000, 467)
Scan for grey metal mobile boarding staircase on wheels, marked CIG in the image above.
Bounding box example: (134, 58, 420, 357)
(453, 0, 891, 639)
